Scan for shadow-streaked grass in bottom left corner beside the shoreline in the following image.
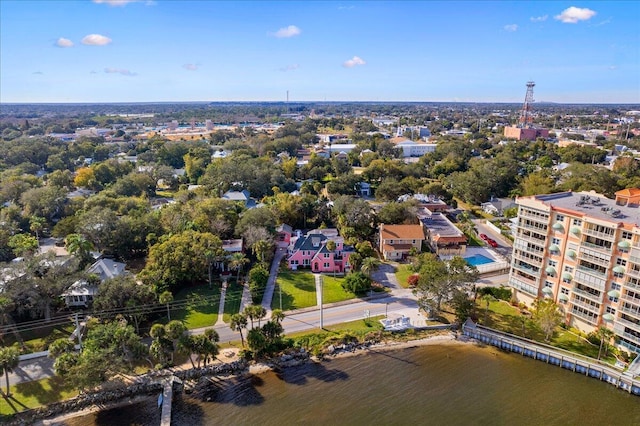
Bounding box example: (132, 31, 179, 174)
(0, 377, 78, 416)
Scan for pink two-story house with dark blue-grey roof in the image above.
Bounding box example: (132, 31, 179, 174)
(288, 229, 354, 273)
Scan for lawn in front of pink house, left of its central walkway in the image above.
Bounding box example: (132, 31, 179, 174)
(271, 270, 317, 311)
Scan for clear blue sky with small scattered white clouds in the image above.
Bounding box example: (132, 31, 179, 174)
(0, 0, 640, 103)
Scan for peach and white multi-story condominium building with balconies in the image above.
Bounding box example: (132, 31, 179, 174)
(509, 188, 640, 353)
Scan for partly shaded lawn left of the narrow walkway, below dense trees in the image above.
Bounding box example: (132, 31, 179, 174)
(171, 283, 220, 329)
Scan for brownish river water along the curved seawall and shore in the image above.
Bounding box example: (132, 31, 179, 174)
(62, 345, 640, 426)
